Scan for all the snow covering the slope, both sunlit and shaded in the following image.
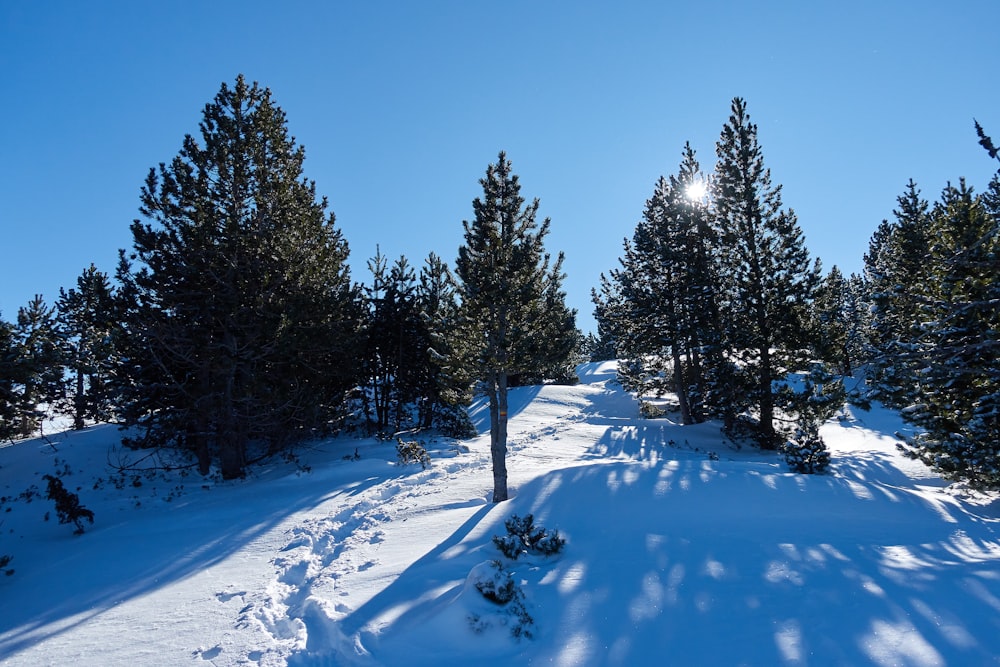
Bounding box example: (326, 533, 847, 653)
(0, 364, 1000, 667)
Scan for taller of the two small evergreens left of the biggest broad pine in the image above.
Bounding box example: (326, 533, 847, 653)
(56, 264, 117, 429)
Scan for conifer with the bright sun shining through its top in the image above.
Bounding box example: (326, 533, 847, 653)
(595, 144, 723, 424)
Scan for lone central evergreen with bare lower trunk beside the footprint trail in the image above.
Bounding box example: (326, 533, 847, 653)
(454, 152, 576, 502)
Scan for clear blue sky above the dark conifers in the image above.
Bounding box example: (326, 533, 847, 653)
(0, 0, 1000, 330)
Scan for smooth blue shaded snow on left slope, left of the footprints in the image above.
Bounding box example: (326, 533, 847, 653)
(0, 427, 402, 656)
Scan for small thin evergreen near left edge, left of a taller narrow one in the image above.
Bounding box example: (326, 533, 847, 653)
(14, 294, 64, 438)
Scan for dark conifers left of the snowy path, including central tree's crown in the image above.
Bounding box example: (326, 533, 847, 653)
(0, 76, 582, 486)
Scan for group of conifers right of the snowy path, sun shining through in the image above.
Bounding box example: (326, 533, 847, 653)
(591, 98, 1000, 488)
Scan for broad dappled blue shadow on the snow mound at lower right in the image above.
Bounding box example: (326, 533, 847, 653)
(343, 443, 1000, 666)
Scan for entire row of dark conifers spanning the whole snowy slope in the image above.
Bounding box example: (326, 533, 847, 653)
(0, 82, 1000, 490)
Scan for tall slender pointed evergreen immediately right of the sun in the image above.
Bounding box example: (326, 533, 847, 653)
(713, 98, 820, 447)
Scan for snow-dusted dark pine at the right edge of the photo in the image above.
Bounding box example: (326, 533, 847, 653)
(904, 177, 1000, 489)
